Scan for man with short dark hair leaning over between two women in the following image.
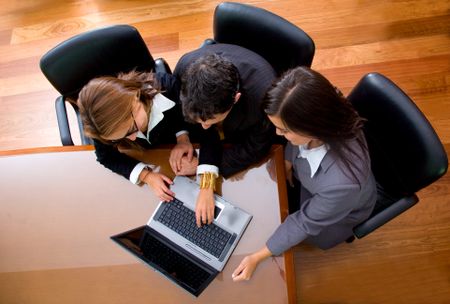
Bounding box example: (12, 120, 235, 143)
(171, 44, 276, 226)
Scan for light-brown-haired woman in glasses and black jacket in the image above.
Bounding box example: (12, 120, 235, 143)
(77, 71, 197, 201)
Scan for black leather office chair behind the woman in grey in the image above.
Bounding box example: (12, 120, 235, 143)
(348, 73, 448, 238)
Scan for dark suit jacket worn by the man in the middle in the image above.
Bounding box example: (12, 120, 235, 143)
(174, 44, 276, 177)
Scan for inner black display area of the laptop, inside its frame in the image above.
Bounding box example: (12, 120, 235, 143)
(141, 233, 211, 290)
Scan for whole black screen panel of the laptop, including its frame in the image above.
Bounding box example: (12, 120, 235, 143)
(112, 226, 217, 296)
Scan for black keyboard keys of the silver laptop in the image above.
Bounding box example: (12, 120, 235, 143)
(155, 198, 232, 258)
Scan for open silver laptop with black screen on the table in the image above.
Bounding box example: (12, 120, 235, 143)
(111, 176, 252, 297)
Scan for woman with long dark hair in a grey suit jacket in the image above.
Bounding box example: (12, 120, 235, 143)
(233, 67, 376, 281)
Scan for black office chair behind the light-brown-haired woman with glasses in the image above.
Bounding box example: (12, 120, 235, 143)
(40, 25, 170, 146)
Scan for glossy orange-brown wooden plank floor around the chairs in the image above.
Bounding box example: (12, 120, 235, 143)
(0, 0, 450, 304)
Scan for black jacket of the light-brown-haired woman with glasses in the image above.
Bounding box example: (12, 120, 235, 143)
(94, 73, 189, 179)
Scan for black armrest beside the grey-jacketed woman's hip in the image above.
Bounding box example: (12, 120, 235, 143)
(353, 194, 419, 239)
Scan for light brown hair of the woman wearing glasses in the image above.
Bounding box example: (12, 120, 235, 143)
(77, 71, 160, 143)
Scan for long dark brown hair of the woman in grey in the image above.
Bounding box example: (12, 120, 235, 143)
(263, 67, 368, 183)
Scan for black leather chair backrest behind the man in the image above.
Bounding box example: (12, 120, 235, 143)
(214, 2, 315, 75)
